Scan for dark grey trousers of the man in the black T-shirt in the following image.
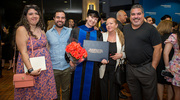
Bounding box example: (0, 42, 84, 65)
(126, 62, 157, 100)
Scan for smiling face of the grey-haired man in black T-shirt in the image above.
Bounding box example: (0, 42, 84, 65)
(130, 8, 144, 29)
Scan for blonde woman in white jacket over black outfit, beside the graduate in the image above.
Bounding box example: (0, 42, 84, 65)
(99, 18, 125, 100)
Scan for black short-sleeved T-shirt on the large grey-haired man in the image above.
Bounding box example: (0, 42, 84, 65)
(123, 22, 161, 64)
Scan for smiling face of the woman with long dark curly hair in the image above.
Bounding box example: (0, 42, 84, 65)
(26, 9, 40, 26)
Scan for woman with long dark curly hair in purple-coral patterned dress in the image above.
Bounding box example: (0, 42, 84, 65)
(14, 5, 57, 100)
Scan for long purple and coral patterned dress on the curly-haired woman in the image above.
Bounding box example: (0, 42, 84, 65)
(14, 33, 57, 100)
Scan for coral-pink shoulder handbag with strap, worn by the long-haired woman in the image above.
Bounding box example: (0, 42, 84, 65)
(13, 35, 35, 88)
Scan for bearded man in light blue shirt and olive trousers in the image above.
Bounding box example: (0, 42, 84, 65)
(46, 10, 72, 100)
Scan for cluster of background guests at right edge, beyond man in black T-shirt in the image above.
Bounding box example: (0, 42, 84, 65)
(145, 15, 180, 100)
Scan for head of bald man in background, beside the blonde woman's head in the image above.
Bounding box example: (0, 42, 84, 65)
(116, 10, 127, 32)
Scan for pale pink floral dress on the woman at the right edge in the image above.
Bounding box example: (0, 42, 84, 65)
(165, 34, 180, 87)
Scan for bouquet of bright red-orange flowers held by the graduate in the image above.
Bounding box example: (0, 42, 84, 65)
(65, 42, 88, 64)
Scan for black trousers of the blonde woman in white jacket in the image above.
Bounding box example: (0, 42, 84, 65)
(100, 66, 119, 100)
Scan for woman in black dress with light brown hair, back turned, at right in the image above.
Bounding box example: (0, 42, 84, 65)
(156, 20, 174, 100)
